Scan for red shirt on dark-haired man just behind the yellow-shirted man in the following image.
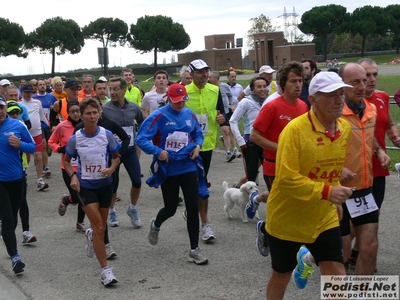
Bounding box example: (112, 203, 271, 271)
(253, 96, 308, 176)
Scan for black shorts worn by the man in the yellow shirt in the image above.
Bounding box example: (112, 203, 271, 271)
(267, 227, 343, 273)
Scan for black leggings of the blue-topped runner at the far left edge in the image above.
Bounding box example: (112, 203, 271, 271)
(0, 178, 25, 256)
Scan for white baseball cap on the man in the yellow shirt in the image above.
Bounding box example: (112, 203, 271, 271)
(308, 72, 352, 95)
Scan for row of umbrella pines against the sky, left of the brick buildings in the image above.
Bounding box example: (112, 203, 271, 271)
(0, 15, 190, 76)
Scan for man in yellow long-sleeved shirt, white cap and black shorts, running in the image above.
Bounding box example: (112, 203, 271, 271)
(265, 72, 352, 300)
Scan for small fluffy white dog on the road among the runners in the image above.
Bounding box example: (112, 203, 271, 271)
(222, 181, 260, 223)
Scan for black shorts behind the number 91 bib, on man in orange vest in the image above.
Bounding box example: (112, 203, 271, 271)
(340, 188, 379, 236)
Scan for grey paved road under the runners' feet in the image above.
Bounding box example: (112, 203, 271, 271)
(0, 151, 400, 300)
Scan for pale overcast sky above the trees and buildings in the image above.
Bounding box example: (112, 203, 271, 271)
(0, 0, 395, 75)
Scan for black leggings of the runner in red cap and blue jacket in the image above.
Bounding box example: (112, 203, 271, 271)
(154, 171, 199, 249)
